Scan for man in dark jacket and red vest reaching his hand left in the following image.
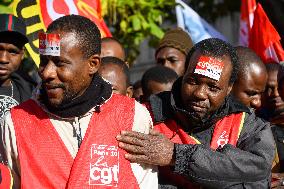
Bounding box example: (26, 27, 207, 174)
(117, 38, 275, 188)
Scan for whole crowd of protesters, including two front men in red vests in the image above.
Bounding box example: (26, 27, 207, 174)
(0, 14, 284, 189)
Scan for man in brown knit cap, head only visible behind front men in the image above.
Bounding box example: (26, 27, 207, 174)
(155, 28, 193, 76)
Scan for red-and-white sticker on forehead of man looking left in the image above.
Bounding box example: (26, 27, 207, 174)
(38, 33, 60, 56)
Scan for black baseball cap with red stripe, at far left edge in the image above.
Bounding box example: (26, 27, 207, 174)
(0, 14, 29, 47)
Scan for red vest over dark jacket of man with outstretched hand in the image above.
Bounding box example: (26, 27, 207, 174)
(155, 112, 245, 188)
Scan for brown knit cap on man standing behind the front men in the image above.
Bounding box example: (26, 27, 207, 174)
(155, 28, 193, 55)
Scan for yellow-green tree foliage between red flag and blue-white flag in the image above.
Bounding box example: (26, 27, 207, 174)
(103, 0, 175, 63)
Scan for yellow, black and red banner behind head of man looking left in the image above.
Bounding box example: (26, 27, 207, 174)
(13, 0, 111, 65)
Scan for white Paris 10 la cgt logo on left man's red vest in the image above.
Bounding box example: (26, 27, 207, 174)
(89, 144, 119, 187)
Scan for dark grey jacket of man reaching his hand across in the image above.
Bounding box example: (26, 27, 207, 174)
(150, 79, 275, 189)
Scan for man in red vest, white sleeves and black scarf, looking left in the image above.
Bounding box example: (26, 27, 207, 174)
(1, 15, 158, 189)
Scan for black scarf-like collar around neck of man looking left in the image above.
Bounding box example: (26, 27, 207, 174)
(37, 74, 112, 118)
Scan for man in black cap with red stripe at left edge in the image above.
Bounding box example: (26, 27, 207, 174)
(0, 14, 33, 118)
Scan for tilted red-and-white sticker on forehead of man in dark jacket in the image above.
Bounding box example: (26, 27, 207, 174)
(194, 56, 224, 81)
